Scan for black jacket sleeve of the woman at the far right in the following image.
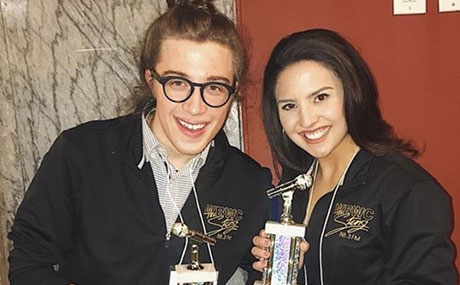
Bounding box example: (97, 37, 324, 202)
(384, 180, 458, 285)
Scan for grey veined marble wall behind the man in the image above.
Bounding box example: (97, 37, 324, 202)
(0, 0, 242, 284)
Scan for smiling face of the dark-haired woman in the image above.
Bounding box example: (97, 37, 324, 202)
(275, 61, 348, 159)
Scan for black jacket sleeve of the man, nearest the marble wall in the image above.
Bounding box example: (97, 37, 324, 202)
(8, 132, 76, 285)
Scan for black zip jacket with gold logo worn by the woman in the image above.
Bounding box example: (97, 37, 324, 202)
(282, 150, 458, 285)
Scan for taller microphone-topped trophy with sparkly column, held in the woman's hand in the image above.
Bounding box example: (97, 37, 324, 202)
(255, 173, 313, 285)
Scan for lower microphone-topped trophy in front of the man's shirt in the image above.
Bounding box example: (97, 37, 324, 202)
(169, 223, 218, 285)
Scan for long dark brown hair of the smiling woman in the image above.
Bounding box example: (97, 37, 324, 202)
(263, 29, 419, 170)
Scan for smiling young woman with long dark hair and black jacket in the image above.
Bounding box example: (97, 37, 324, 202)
(253, 29, 457, 285)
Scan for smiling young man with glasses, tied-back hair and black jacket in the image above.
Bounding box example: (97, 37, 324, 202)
(9, 0, 271, 285)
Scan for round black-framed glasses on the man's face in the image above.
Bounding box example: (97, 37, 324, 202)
(150, 69, 236, 108)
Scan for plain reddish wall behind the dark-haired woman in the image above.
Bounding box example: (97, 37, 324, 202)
(237, 0, 460, 267)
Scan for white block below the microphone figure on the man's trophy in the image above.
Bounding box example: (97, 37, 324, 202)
(169, 263, 218, 285)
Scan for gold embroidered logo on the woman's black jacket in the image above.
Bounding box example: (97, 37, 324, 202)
(324, 203, 375, 242)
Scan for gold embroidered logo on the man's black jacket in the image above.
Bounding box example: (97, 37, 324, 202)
(204, 204, 243, 240)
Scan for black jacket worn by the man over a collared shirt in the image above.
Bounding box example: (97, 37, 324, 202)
(9, 114, 271, 285)
